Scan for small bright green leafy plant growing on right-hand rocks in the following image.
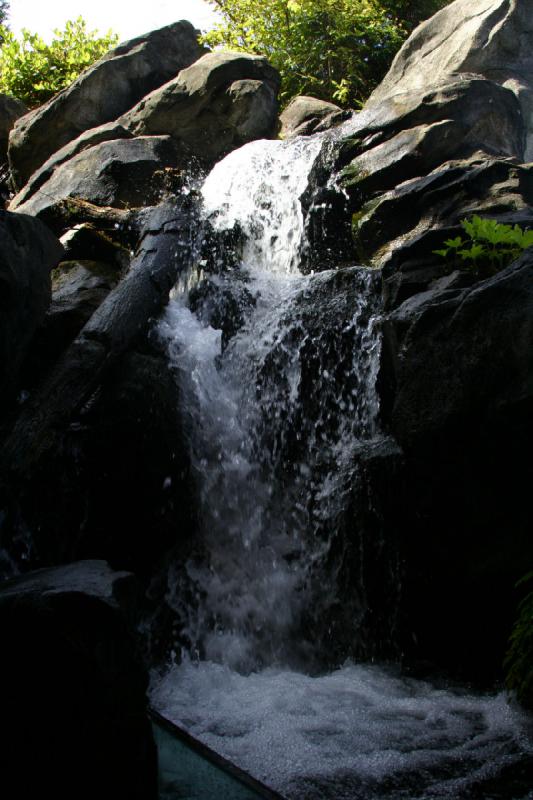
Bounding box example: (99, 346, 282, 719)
(433, 214, 533, 274)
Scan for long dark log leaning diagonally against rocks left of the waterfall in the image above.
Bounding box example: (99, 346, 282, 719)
(0, 197, 197, 482)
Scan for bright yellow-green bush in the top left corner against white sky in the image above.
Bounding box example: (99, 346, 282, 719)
(0, 17, 118, 107)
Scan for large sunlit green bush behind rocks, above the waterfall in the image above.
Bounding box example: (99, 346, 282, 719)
(204, 0, 449, 106)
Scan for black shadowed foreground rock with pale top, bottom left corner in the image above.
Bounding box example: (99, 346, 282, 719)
(0, 561, 157, 800)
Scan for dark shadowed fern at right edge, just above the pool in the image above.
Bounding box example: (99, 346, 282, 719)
(505, 572, 533, 709)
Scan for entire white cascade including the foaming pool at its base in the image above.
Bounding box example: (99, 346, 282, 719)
(152, 123, 528, 799)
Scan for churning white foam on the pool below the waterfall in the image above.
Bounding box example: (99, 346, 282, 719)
(152, 662, 532, 800)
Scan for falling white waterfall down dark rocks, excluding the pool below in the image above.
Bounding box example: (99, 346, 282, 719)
(161, 130, 380, 671)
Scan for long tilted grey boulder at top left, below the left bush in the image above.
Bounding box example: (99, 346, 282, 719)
(9, 21, 205, 188)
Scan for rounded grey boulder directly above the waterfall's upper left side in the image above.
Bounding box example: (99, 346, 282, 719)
(119, 52, 280, 164)
